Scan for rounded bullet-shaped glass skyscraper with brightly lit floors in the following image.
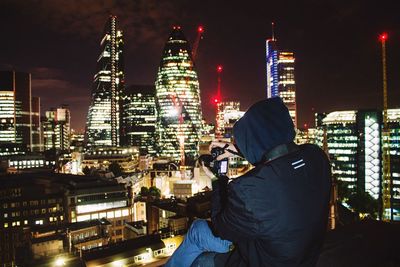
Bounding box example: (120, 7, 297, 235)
(156, 26, 202, 161)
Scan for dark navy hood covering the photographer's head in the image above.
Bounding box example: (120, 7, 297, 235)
(233, 97, 296, 165)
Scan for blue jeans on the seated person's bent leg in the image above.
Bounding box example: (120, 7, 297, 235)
(164, 220, 232, 267)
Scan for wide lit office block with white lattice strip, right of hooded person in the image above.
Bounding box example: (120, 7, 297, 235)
(316, 109, 400, 220)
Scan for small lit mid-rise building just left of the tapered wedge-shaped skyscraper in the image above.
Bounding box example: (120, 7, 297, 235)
(42, 106, 71, 151)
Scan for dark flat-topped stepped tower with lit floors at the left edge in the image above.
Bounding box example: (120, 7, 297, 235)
(0, 71, 41, 151)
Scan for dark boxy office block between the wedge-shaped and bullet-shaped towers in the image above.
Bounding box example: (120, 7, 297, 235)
(121, 85, 157, 156)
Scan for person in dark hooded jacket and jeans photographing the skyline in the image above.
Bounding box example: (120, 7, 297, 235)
(165, 97, 331, 267)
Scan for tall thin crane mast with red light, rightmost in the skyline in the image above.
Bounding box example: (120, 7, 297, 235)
(379, 33, 393, 221)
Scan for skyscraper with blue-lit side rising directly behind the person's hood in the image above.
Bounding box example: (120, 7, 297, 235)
(266, 37, 297, 127)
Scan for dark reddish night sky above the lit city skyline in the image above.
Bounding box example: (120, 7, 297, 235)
(0, 0, 400, 130)
